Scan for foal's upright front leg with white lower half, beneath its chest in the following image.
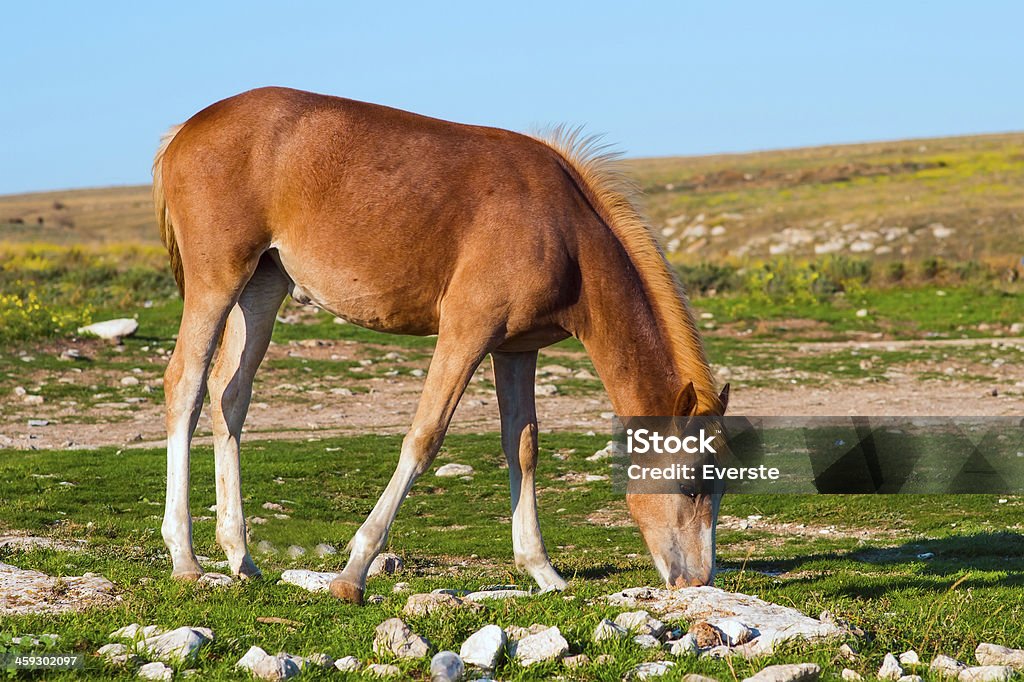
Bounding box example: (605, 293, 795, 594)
(490, 351, 566, 590)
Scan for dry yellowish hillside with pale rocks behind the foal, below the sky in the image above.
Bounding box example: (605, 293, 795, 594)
(0, 133, 1024, 265)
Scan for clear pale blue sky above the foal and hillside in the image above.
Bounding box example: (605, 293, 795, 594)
(0, 0, 1024, 194)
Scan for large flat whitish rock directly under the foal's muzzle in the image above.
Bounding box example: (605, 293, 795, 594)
(605, 587, 849, 656)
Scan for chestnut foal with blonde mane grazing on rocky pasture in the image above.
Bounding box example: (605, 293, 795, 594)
(154, 88, 727, 602)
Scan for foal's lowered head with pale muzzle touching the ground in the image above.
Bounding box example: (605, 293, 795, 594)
(626, 384, 729, 588)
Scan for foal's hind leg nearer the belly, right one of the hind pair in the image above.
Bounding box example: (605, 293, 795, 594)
(209, 256, 288, 578)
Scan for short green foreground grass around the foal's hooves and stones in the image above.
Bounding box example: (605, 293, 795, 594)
(0, 434, 1024, 680)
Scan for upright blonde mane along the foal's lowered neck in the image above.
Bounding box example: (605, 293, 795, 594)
(536, 127, 722, 414)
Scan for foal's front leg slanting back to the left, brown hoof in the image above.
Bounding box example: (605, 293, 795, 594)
(331, 328, 490, 603)
